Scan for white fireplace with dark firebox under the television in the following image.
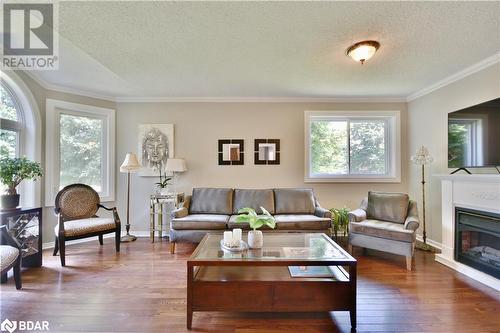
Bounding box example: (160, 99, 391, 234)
(435, 174, 500, 291)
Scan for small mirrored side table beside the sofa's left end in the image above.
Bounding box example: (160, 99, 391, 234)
(149, 193, 184, 243)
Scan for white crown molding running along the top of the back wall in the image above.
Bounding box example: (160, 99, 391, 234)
(115, 96, 406, 103)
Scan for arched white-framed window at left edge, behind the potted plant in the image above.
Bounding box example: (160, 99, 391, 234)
(0, 71, 42, 206)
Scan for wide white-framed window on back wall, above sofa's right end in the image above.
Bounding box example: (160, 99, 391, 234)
(305, 111, 401, 182)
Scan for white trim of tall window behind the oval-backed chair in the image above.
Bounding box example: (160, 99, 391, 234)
(45, 99, 115, 207)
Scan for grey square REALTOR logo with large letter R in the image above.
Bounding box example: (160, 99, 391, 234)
(2, 2, 58, 70)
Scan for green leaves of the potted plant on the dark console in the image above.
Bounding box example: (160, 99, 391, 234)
(0, 156, 43, 194)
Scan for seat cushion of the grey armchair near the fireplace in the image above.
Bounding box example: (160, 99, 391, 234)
(349, 220, 415, 243)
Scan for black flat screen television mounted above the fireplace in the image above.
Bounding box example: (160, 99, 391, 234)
(448, 98, 500, 168)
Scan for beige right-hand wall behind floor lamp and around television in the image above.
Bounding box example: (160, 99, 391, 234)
(408, 63, 500, 243)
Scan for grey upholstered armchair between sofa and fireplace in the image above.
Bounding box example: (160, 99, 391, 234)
(349, 192, 420, 271)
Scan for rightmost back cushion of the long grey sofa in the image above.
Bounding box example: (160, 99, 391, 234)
(274, 188, 316, 214)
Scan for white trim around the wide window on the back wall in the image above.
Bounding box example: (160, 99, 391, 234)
(304, 110, 401, 183)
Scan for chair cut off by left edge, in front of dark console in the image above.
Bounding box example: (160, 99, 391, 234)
(0, 225, 22, 289)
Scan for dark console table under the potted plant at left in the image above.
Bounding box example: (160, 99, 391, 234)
(0, 207, 42, 267)
